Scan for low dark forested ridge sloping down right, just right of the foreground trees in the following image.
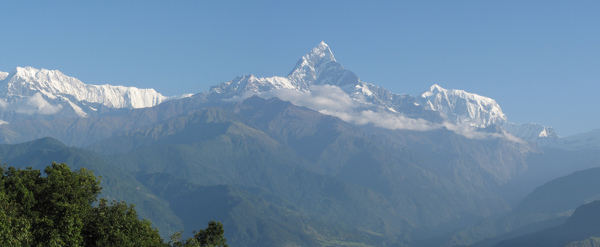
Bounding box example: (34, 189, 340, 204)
(139, 174, 373, 246)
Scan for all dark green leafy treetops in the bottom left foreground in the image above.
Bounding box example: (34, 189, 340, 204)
(0, 163, 227, 246)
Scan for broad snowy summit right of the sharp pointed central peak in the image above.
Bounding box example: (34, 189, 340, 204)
(421, 84, 506, 128)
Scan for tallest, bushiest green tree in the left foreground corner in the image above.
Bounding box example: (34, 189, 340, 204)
(0, 163, 101, 246)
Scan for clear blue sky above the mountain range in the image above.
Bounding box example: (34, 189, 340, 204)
(0, 0, 600, 136)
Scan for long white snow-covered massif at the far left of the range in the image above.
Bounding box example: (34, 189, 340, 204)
(0, 67, 167, 117)
